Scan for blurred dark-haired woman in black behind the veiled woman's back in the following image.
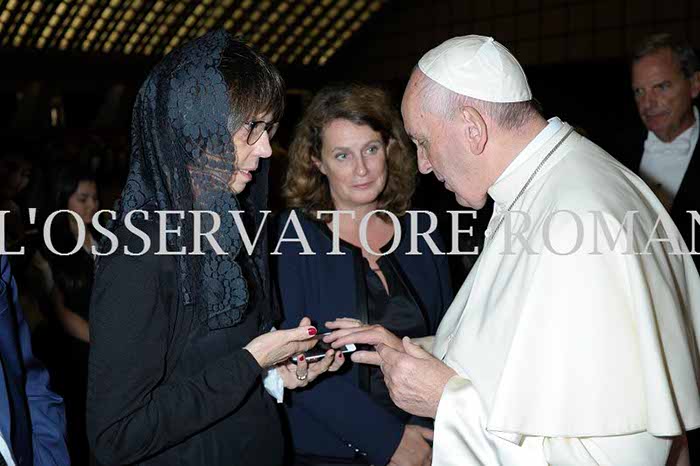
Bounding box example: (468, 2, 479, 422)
(39, 166, 99, 465)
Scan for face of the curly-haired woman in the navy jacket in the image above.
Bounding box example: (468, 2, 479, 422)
(314, 119, 387, 209)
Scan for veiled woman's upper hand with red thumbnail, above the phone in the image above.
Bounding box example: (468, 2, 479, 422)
(243, 317, 317, 369)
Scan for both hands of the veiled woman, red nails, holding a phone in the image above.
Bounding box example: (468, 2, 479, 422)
(244, 317, 345, 389)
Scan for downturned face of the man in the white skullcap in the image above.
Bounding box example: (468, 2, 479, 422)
(401, 78, 488, 209)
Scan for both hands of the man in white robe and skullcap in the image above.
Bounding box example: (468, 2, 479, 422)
(323, 318, 456, 419)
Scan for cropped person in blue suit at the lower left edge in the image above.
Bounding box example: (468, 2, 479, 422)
(0, 256, 70, 466)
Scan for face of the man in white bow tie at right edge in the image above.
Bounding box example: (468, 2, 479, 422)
(632, 49, 700, 142)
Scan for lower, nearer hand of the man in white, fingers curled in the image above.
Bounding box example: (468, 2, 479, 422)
(374, 337, 457, 419)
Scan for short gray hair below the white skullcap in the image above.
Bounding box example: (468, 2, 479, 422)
(421, 76, 539, 130)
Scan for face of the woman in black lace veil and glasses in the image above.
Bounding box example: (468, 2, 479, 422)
(228, 113, 272, 194)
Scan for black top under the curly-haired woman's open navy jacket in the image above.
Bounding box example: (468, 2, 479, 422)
(363, 256, 430, 423)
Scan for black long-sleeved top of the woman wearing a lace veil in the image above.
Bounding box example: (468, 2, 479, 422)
(87, 221, 283, 466)
